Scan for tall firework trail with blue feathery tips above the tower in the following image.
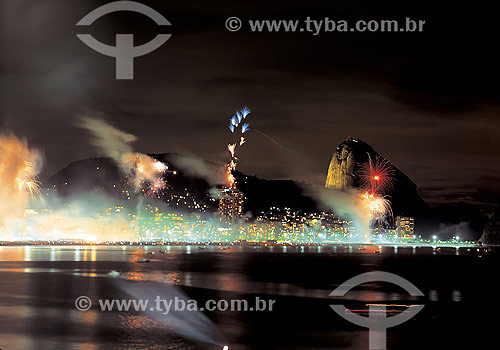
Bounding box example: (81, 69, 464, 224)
(225, 107, 251, 188)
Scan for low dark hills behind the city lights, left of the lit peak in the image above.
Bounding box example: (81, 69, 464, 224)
(44, 153, 316, 215)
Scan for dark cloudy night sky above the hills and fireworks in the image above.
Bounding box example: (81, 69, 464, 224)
(0, 0, 500, 210)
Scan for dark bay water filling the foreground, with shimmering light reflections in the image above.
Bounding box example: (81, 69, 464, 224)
(0, 246, 500, 350)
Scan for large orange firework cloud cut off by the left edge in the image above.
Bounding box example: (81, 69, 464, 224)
(0, 135, 42, 226)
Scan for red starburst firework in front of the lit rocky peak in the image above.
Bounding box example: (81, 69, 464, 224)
(360, 155, 394, 194)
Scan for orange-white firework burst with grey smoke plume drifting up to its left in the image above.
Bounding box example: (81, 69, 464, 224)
(79, 116, 168, 197)
